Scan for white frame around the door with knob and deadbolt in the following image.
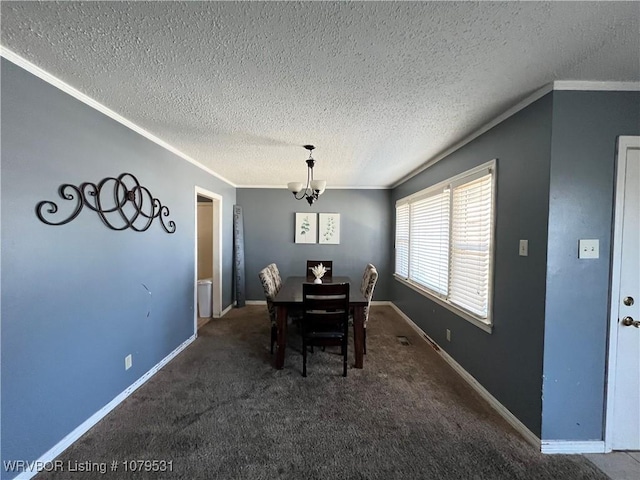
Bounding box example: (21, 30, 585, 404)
(604, 135, 640, 453)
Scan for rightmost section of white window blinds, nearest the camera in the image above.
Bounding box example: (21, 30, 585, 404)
(449, 174, 493, 318)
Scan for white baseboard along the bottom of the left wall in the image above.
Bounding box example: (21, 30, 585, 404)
(14, 335, 196, 480)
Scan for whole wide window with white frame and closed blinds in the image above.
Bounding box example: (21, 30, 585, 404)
(395, 160, 496, 326)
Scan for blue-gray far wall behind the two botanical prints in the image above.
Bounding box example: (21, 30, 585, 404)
(237, 188, 393, 301)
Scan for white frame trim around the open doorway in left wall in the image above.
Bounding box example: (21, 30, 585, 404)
(193, 185, 222, 335)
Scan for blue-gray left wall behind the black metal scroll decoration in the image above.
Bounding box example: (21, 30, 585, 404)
(1, 59, 235, 478)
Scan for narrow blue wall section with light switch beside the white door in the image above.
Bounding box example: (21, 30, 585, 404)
(542, 91, 640, 440)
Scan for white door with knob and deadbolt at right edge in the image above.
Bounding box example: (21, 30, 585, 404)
(606, 137, 640, 450)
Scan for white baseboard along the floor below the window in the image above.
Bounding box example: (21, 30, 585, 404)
(391, 303, 541, 449)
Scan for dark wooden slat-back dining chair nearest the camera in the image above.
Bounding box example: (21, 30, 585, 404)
(302, 283, 349, 377)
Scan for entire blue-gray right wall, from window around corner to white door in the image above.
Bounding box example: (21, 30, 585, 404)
(392, 91, 640, 441)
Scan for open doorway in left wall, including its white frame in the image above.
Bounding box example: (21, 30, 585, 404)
(194, 187, 222, 333)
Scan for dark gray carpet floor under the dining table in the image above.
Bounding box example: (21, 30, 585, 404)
(36, 306, 607, 480)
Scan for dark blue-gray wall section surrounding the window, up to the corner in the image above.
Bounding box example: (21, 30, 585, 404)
(392, 95, 551, 435)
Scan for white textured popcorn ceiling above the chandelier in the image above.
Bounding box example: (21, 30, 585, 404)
(1, 1, 640, 188)
